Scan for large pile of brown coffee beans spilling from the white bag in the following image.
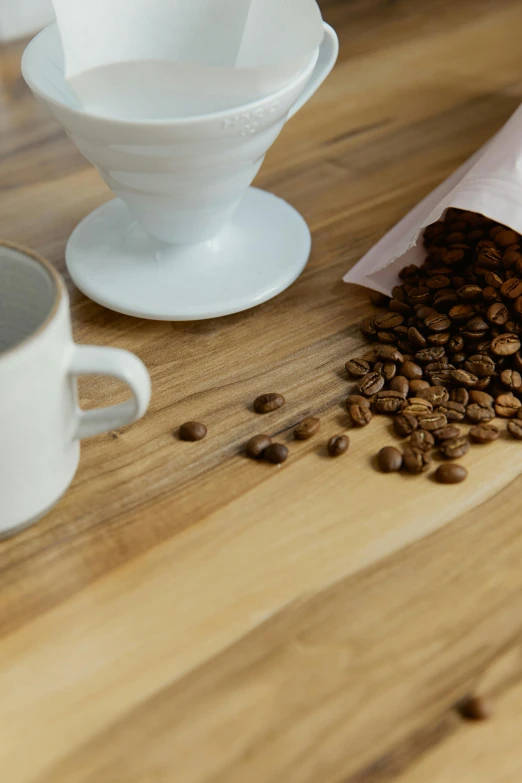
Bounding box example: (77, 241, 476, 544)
(346, 209, 522, 484)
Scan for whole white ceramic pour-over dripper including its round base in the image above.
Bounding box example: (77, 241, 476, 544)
(22, 25, 338, 321)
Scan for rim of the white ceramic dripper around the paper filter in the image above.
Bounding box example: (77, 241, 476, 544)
(21, 20, 320, 128)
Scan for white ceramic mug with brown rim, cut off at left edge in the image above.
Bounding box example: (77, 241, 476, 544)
(0, 243, 151, 536)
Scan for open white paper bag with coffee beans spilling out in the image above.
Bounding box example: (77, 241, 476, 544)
(344, 106, 522, 295)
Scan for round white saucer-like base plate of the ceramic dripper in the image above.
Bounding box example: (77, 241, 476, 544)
(66, 188, 311, 321)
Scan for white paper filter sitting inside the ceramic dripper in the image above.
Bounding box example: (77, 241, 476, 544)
(53, 0, 324, 120)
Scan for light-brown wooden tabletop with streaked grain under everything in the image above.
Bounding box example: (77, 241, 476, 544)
(0, 0, 522, 783)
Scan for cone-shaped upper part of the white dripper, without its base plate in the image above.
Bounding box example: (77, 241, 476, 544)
(22, 24, 339, 245)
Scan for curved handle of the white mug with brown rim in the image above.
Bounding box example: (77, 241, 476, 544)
(69, 345, 151, 440)
